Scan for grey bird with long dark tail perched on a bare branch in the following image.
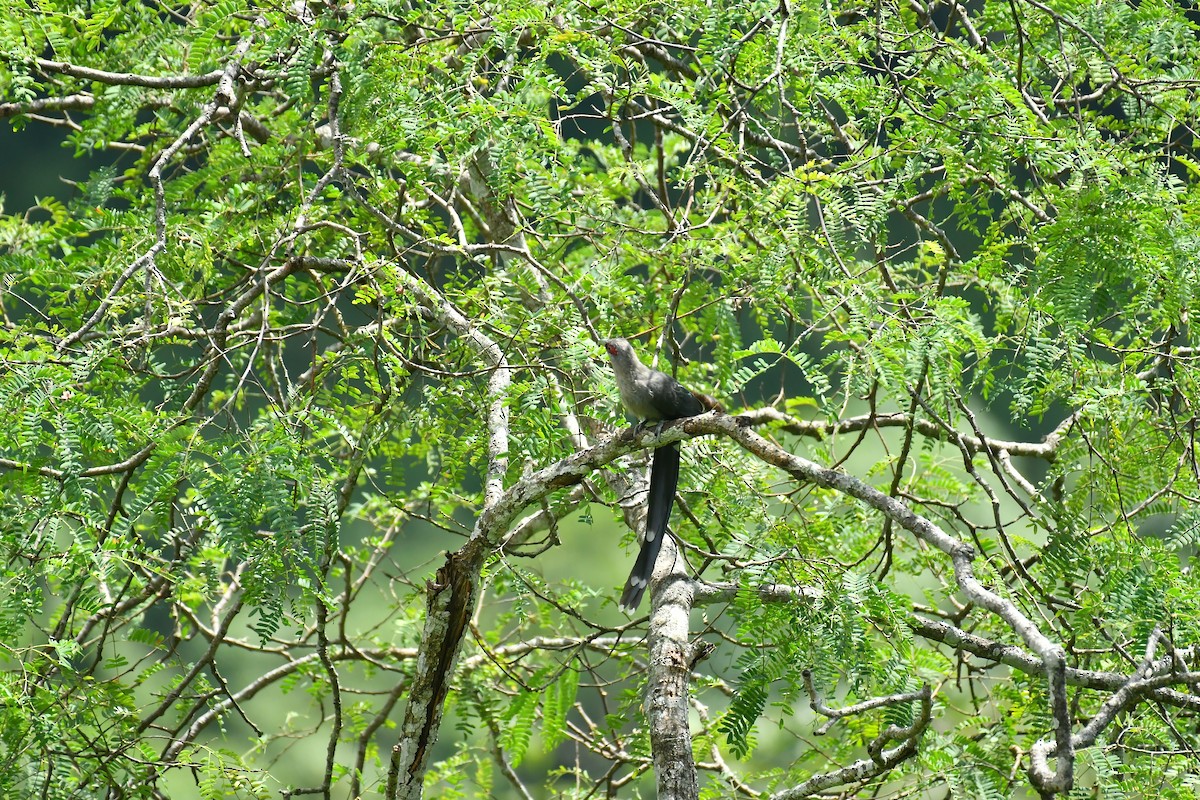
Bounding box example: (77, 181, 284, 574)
(604, 338, 720, 612)
